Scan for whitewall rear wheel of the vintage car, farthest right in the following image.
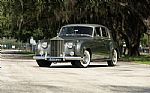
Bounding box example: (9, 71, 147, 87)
(107, 49, 118, 66)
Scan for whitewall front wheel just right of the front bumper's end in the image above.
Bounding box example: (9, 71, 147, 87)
(73, 50, 91, 67)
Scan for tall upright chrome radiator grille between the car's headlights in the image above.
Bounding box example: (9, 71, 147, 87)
(50, 37, 64, 57)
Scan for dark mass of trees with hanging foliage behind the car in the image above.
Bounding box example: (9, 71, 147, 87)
(0, 0, 150, 56)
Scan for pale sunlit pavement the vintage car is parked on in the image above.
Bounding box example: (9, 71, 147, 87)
(0, 58, 150, 93)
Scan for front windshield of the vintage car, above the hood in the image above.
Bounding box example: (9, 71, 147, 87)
(59, 26, 93, 36)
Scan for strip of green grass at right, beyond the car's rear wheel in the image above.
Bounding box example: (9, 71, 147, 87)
(121, 55, 150, 65)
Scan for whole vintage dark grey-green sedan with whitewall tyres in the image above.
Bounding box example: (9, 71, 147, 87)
(33, 24, 119, 67)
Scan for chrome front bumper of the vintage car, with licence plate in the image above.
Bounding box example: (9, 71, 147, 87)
(33, 56, 83, 62)
